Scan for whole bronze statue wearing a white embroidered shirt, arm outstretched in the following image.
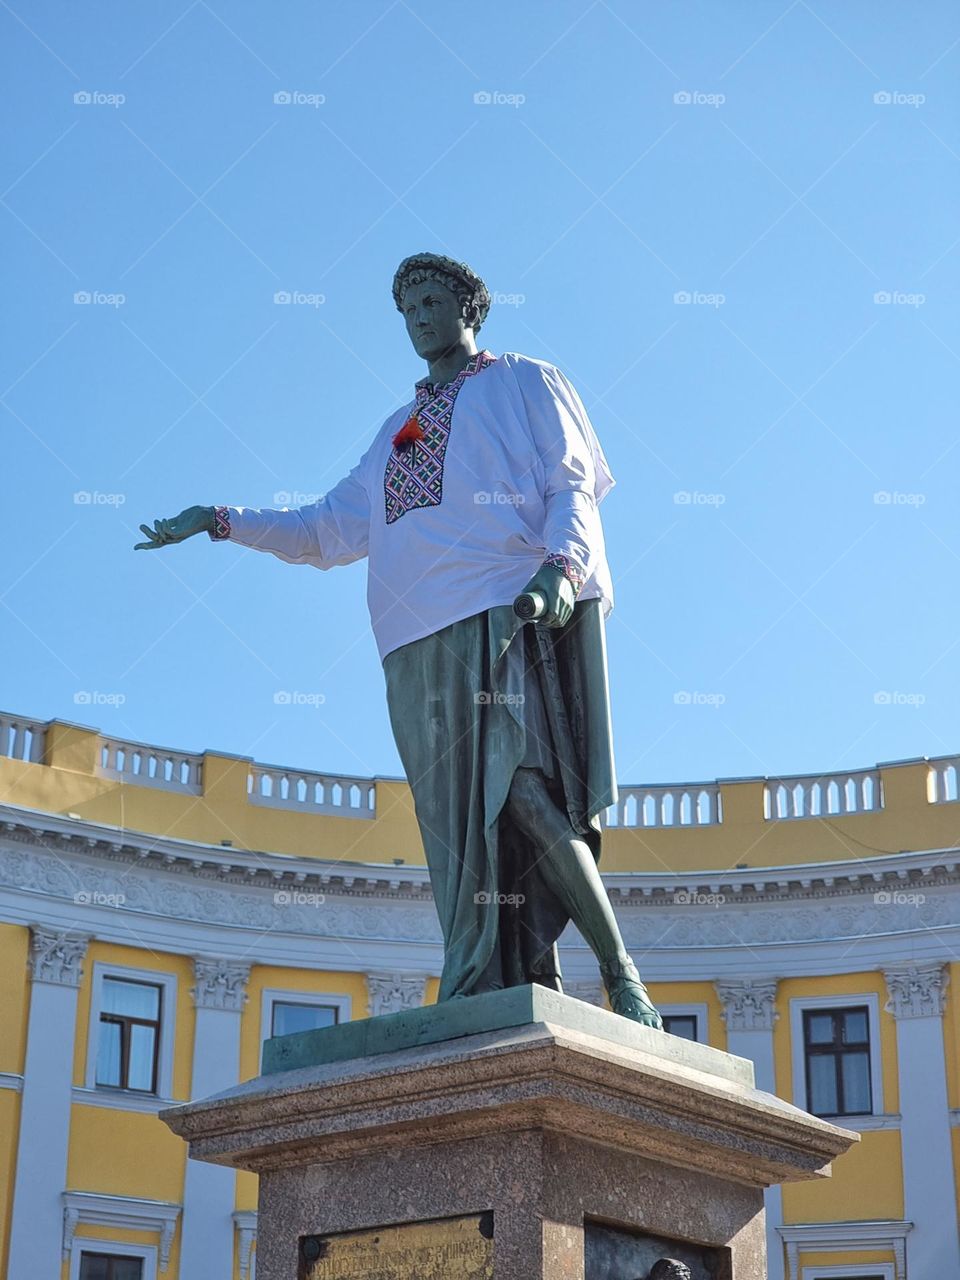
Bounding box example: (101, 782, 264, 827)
(136, 253, 663, 1028)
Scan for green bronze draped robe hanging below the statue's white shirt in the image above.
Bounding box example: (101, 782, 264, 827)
(383, 599, 617, 1000)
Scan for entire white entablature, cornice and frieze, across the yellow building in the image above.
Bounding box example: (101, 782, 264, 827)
(0, 805, 960, 967)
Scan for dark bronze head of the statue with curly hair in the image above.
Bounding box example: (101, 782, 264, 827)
(393, 253, 490, 362)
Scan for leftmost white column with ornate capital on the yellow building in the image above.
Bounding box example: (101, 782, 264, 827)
(10, 925, 90, 1276)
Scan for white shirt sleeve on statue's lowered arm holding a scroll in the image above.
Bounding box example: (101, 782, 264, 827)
(521, 364, 616, 591)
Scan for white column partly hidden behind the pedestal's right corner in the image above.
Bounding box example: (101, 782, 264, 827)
(714, 978, 783, 1280)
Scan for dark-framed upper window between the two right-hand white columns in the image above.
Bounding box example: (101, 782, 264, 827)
(804, 1005, 873, 1116)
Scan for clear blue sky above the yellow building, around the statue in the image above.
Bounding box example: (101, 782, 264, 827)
(0, 0, 960, 783)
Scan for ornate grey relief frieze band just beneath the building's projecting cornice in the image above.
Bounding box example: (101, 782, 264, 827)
(0, 846, 960, 951)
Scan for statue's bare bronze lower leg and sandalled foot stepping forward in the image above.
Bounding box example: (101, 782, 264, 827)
(507, 768, 663, 1028)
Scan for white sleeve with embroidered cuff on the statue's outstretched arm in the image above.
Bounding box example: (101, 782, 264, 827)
(210, 454, 370, 570)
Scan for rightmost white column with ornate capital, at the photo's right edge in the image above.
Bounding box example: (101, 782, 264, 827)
(883, 963, 960, 1280)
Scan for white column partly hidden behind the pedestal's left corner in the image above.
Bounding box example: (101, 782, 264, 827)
(180, 956, 250, 1280)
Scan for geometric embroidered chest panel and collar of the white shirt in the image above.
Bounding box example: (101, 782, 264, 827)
(383, 351, 497, 525)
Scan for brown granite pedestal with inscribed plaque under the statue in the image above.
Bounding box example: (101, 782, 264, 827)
(161, 987, 858, 1280)
